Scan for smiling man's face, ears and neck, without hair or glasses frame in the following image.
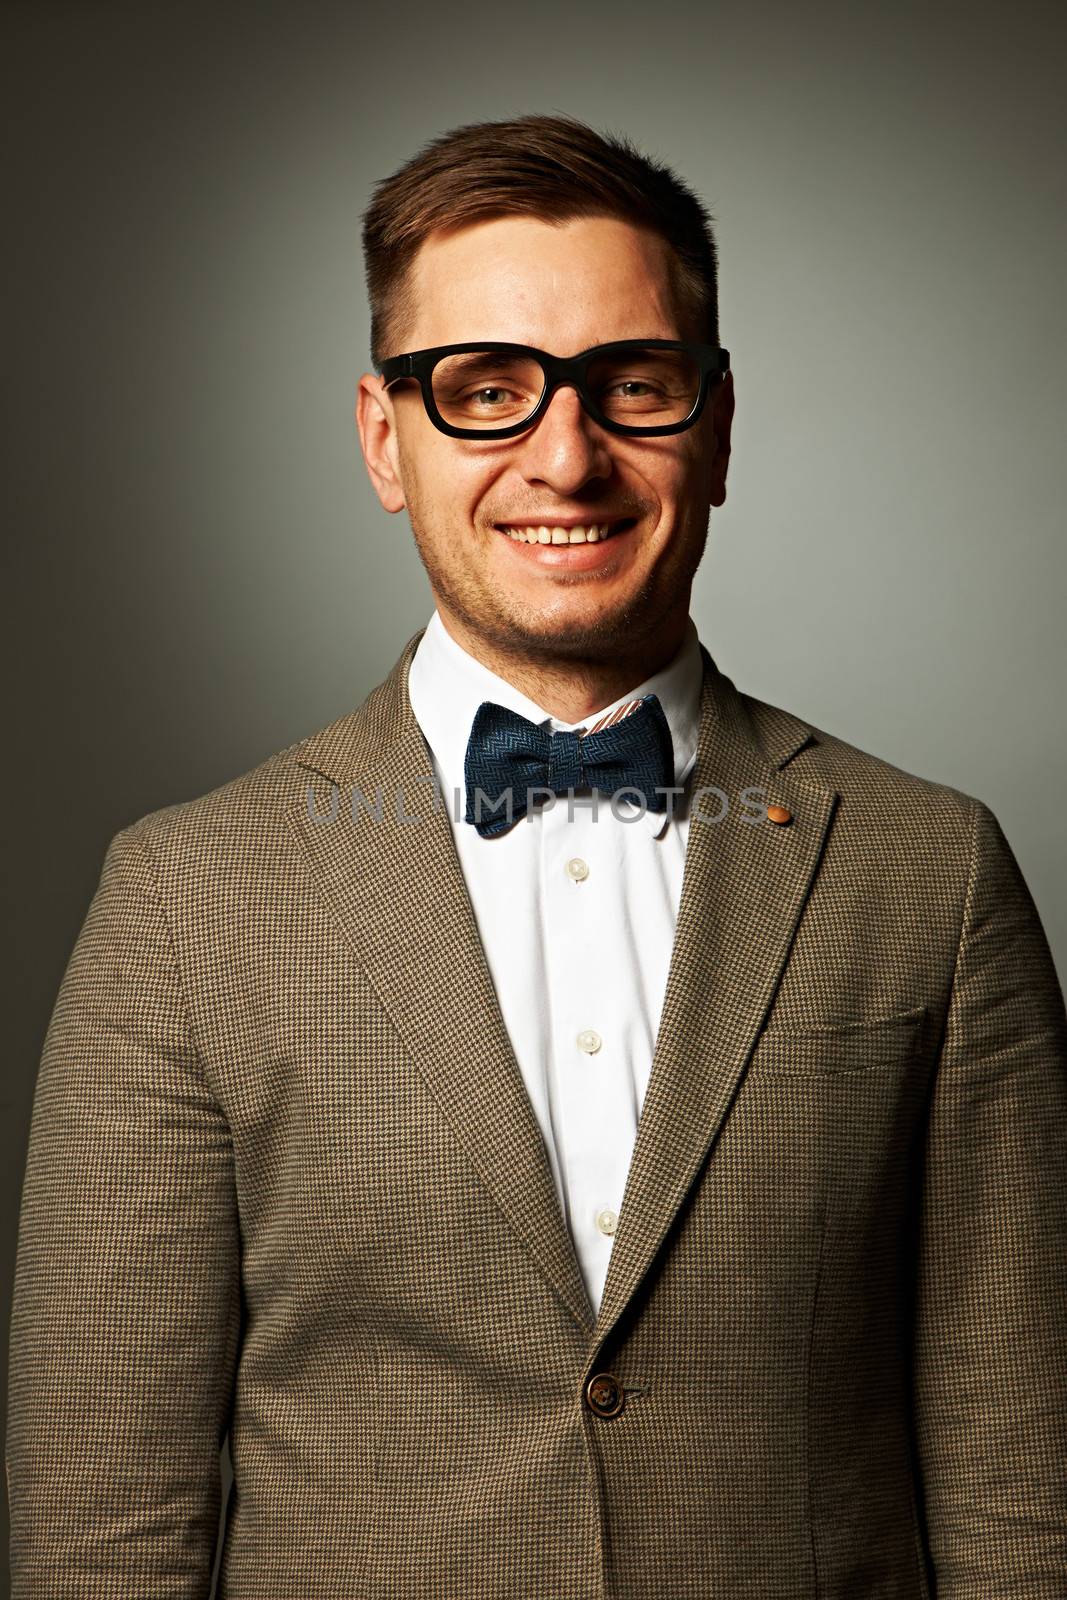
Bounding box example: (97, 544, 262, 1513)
(358, 206, 733, 707)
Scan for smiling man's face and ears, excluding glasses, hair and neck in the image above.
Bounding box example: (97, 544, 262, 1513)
(357, 216, 733, 659)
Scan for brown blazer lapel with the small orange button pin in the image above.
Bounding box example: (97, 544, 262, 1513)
(593, 646, 838, 1347)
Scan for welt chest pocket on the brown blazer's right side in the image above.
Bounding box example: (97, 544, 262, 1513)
(749, 1006, 926, 1077)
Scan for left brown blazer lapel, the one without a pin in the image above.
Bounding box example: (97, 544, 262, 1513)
(286, 630, 593, 1334)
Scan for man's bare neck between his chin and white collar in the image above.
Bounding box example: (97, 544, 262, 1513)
(438, 603, 689, 723)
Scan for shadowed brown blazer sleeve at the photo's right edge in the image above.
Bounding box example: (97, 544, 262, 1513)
(915, 802, 1067, 1600)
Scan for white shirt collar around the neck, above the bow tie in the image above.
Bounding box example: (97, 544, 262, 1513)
(408, 610, 704, 837)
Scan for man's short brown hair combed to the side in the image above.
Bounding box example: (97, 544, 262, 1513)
(363, 115, 718, 371)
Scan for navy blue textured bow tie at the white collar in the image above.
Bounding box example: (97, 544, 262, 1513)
(464, 694, 673, 838)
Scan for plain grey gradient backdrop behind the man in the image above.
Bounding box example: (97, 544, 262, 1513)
(0, 0, 1067, 1580)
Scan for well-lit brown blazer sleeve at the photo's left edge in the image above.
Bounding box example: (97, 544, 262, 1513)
(5, 824, 240, 1600)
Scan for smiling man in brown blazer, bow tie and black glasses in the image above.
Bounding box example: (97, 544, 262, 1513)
(6, 117, 1067, 1600)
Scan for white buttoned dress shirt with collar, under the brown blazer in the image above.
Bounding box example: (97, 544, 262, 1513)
(408, 611, 702, 1309)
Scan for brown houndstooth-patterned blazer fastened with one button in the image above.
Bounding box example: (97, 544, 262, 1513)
(6, 634, 1067, 1600)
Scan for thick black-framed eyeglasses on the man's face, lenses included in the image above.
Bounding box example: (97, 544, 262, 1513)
(381, 339, 729, 438)
